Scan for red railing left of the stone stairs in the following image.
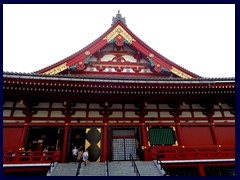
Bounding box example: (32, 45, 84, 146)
(3, 151, 60, 164)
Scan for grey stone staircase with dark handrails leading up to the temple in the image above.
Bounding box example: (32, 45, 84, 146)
(47, 161, 165, 176)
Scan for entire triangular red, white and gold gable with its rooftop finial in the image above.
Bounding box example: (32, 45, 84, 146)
(38, 12, 199, 78)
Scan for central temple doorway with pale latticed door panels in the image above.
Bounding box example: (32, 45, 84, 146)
(111, 129, 138, 161)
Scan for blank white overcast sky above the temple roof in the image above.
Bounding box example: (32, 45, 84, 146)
(3, 4, 235, 77)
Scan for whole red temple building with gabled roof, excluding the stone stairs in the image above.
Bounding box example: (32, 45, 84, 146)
(3, 12, 235, 176)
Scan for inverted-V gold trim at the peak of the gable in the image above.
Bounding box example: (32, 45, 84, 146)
(103, 25, 136, 44)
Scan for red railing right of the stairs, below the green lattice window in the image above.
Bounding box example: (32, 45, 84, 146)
(152, 146, 235, 160)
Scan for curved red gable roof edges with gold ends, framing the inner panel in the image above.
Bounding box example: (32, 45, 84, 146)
(35, 11, 200, 78)
